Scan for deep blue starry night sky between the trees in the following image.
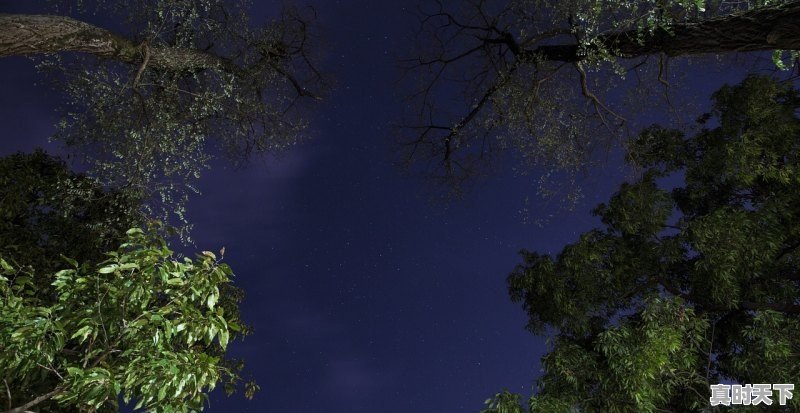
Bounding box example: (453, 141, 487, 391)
(0, 0, 764, 413)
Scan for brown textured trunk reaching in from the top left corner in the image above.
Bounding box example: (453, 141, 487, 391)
(0, 14, 239, 72)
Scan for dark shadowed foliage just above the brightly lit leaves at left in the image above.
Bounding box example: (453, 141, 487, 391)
(0, 150, 145, 289)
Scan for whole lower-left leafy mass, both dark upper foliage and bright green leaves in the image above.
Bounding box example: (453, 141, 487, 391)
(0, 151, 258, 412)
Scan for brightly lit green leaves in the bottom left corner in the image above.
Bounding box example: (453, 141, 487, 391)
(0, 229, 250, 412)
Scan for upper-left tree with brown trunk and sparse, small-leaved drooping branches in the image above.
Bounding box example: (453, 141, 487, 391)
(0, 0, 323, 225)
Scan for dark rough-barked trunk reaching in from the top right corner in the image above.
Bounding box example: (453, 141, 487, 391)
(521, 1, 800, 63)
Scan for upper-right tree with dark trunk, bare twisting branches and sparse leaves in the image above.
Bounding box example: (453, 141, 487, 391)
(401, 0, 800, 195)
